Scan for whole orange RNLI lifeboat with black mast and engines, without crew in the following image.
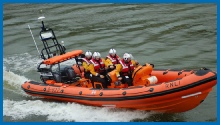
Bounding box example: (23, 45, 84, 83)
(21, 15, 217, 113)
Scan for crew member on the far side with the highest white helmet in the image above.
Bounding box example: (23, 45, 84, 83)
(105, 49, 120, 72)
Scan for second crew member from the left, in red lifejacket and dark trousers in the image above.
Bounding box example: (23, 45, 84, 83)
(89, 52, 107, 88)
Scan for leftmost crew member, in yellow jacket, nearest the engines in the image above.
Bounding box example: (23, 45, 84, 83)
(82, 51, 92, 79)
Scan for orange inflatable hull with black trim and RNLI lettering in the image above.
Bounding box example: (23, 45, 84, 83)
(21, 69, 217, 113)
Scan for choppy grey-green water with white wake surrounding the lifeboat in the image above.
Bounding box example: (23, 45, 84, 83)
(3, 4, 217, 122)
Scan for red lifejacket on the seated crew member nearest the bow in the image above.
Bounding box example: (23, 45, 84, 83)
(119, 59, 134, 75)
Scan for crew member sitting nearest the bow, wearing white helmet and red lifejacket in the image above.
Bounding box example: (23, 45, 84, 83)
(115, 53, 138, 86)
